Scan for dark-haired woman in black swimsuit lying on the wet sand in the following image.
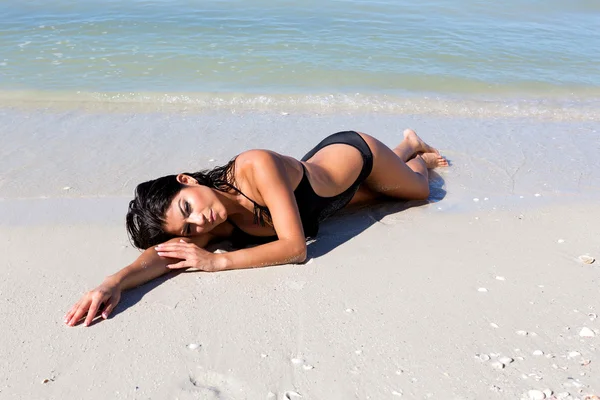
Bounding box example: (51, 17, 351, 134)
(65, 129, 448, 326)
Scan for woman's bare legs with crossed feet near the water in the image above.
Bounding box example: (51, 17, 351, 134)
(352, 129, 448, 203)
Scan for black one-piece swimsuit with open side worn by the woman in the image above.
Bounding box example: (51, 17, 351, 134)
(228, 131, 373, 247)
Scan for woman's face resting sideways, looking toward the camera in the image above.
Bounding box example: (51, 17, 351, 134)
(165, 175, 227, 236)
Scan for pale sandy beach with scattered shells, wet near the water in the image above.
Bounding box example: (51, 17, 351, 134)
(0, 110, 600, 399)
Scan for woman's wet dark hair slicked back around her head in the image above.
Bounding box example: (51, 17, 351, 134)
(125, 158, 235, 250)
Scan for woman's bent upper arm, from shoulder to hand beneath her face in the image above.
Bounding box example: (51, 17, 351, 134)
(157, 150, 306, 271)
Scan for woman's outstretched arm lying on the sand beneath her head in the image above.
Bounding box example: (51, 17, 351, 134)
(64, 234, 213, 326)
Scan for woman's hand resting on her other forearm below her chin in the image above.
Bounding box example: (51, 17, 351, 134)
(155, 240, 225, 272)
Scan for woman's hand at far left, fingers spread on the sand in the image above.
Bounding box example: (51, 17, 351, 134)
(65, 277, 121, 326)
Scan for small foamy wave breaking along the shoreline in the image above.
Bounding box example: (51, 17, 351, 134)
(0, 91, 600, 121)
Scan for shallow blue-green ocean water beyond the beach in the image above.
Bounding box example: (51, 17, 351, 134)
(0, 0, 600, 119)
